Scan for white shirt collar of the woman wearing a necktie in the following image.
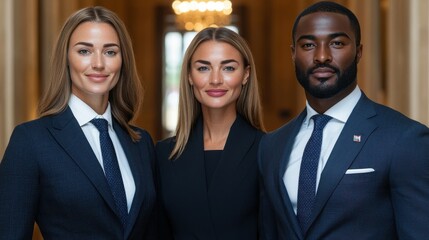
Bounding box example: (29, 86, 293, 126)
(68, 94, 112, 127)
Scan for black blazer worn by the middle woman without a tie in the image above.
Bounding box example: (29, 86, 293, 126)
(156, 116, 263, 240)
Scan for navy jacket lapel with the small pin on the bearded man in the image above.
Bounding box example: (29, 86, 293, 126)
(310, 93, 377, 227)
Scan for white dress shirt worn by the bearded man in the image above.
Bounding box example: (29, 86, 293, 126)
(283, 86, 362, 214)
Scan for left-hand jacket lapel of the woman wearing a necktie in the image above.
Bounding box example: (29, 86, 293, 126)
(49, 107, 118, 214)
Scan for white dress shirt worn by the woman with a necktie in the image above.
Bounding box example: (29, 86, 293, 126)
(68, 94, 136, 212)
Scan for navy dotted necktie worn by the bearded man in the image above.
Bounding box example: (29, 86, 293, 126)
(297, 114, 331, 233)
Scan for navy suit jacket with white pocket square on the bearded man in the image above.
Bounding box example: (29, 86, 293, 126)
(258, 94, 429, 240)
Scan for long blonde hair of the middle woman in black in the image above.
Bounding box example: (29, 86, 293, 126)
(170, 27, 265, 159)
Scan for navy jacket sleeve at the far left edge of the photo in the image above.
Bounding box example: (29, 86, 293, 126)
(0, 125, 39, 240)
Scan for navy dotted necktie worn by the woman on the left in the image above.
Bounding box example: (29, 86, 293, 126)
(91, 118, 128, 227)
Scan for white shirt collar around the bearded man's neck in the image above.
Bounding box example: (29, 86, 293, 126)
(304, 86, 362, 126)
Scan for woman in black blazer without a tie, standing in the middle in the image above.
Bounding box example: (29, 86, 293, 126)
(156, 28, 264, 240)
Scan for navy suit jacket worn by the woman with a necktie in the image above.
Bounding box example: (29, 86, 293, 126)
(0, 108, 156, 240)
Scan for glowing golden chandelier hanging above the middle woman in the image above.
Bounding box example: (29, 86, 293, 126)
(172, 0, 232, 32)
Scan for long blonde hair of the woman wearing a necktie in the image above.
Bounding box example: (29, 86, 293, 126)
(39, 6, 143, 141)
